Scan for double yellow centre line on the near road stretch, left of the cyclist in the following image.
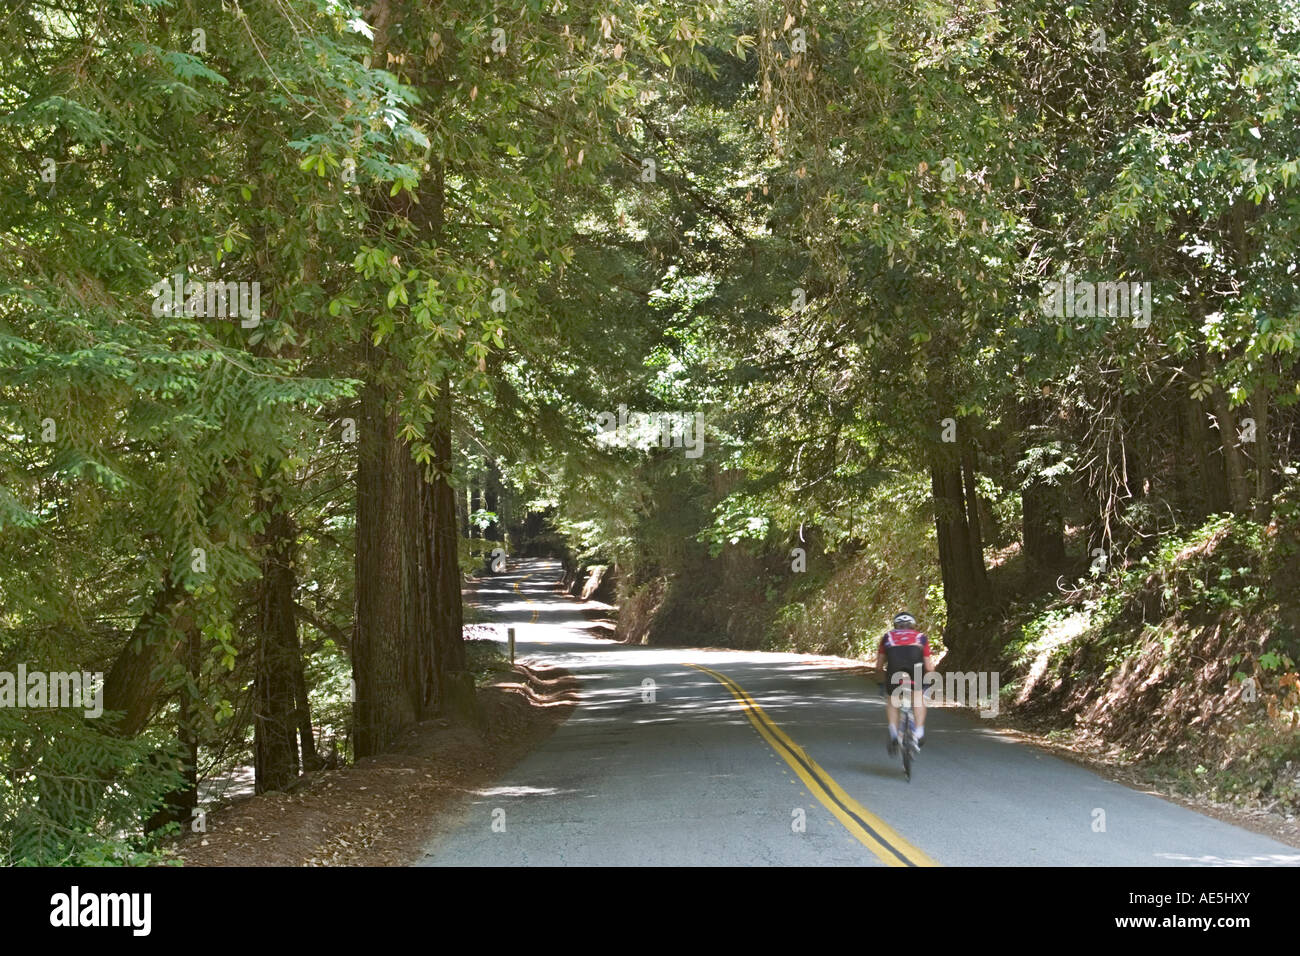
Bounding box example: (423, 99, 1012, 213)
(686, 663, 939, 866)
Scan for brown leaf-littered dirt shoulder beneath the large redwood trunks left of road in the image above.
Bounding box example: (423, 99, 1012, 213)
(177, 665, 577, 866)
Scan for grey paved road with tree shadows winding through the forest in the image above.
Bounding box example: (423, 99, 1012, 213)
(421, 562, 1300, 866)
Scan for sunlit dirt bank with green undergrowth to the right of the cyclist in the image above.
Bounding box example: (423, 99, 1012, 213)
(982, 515, 1300, 844)
